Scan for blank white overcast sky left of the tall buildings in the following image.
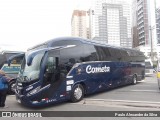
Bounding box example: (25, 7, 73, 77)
(0, 0, 159, 49)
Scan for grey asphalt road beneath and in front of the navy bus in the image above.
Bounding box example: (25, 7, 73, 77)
(0, 75, 160, 120)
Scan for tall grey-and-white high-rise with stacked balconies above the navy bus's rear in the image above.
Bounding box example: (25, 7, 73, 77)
(132, 0, 150, 47)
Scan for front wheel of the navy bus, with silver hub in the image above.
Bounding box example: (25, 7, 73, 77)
(71, 84, 84, 102)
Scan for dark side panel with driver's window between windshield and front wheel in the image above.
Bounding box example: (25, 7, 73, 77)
(43, 50, 66, 99)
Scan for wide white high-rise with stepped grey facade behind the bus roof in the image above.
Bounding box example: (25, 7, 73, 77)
(92, 0, 132, 48)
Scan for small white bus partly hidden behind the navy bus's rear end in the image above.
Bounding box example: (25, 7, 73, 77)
(145, 59, 154, 75)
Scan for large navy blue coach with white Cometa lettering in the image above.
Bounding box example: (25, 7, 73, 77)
(10, 37, 145, 107)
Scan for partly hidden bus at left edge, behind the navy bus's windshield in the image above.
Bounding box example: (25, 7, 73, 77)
(0, 50, 24, 94)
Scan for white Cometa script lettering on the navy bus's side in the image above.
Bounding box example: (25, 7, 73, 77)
(86, 65, 110, 74)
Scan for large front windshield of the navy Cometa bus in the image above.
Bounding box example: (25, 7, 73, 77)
(18, 52, 44, 82)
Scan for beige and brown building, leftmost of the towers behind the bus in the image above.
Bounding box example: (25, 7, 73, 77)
(71, 10, 90, 39)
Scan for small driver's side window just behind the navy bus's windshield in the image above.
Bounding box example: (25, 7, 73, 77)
(46, 57, 56, 73)
